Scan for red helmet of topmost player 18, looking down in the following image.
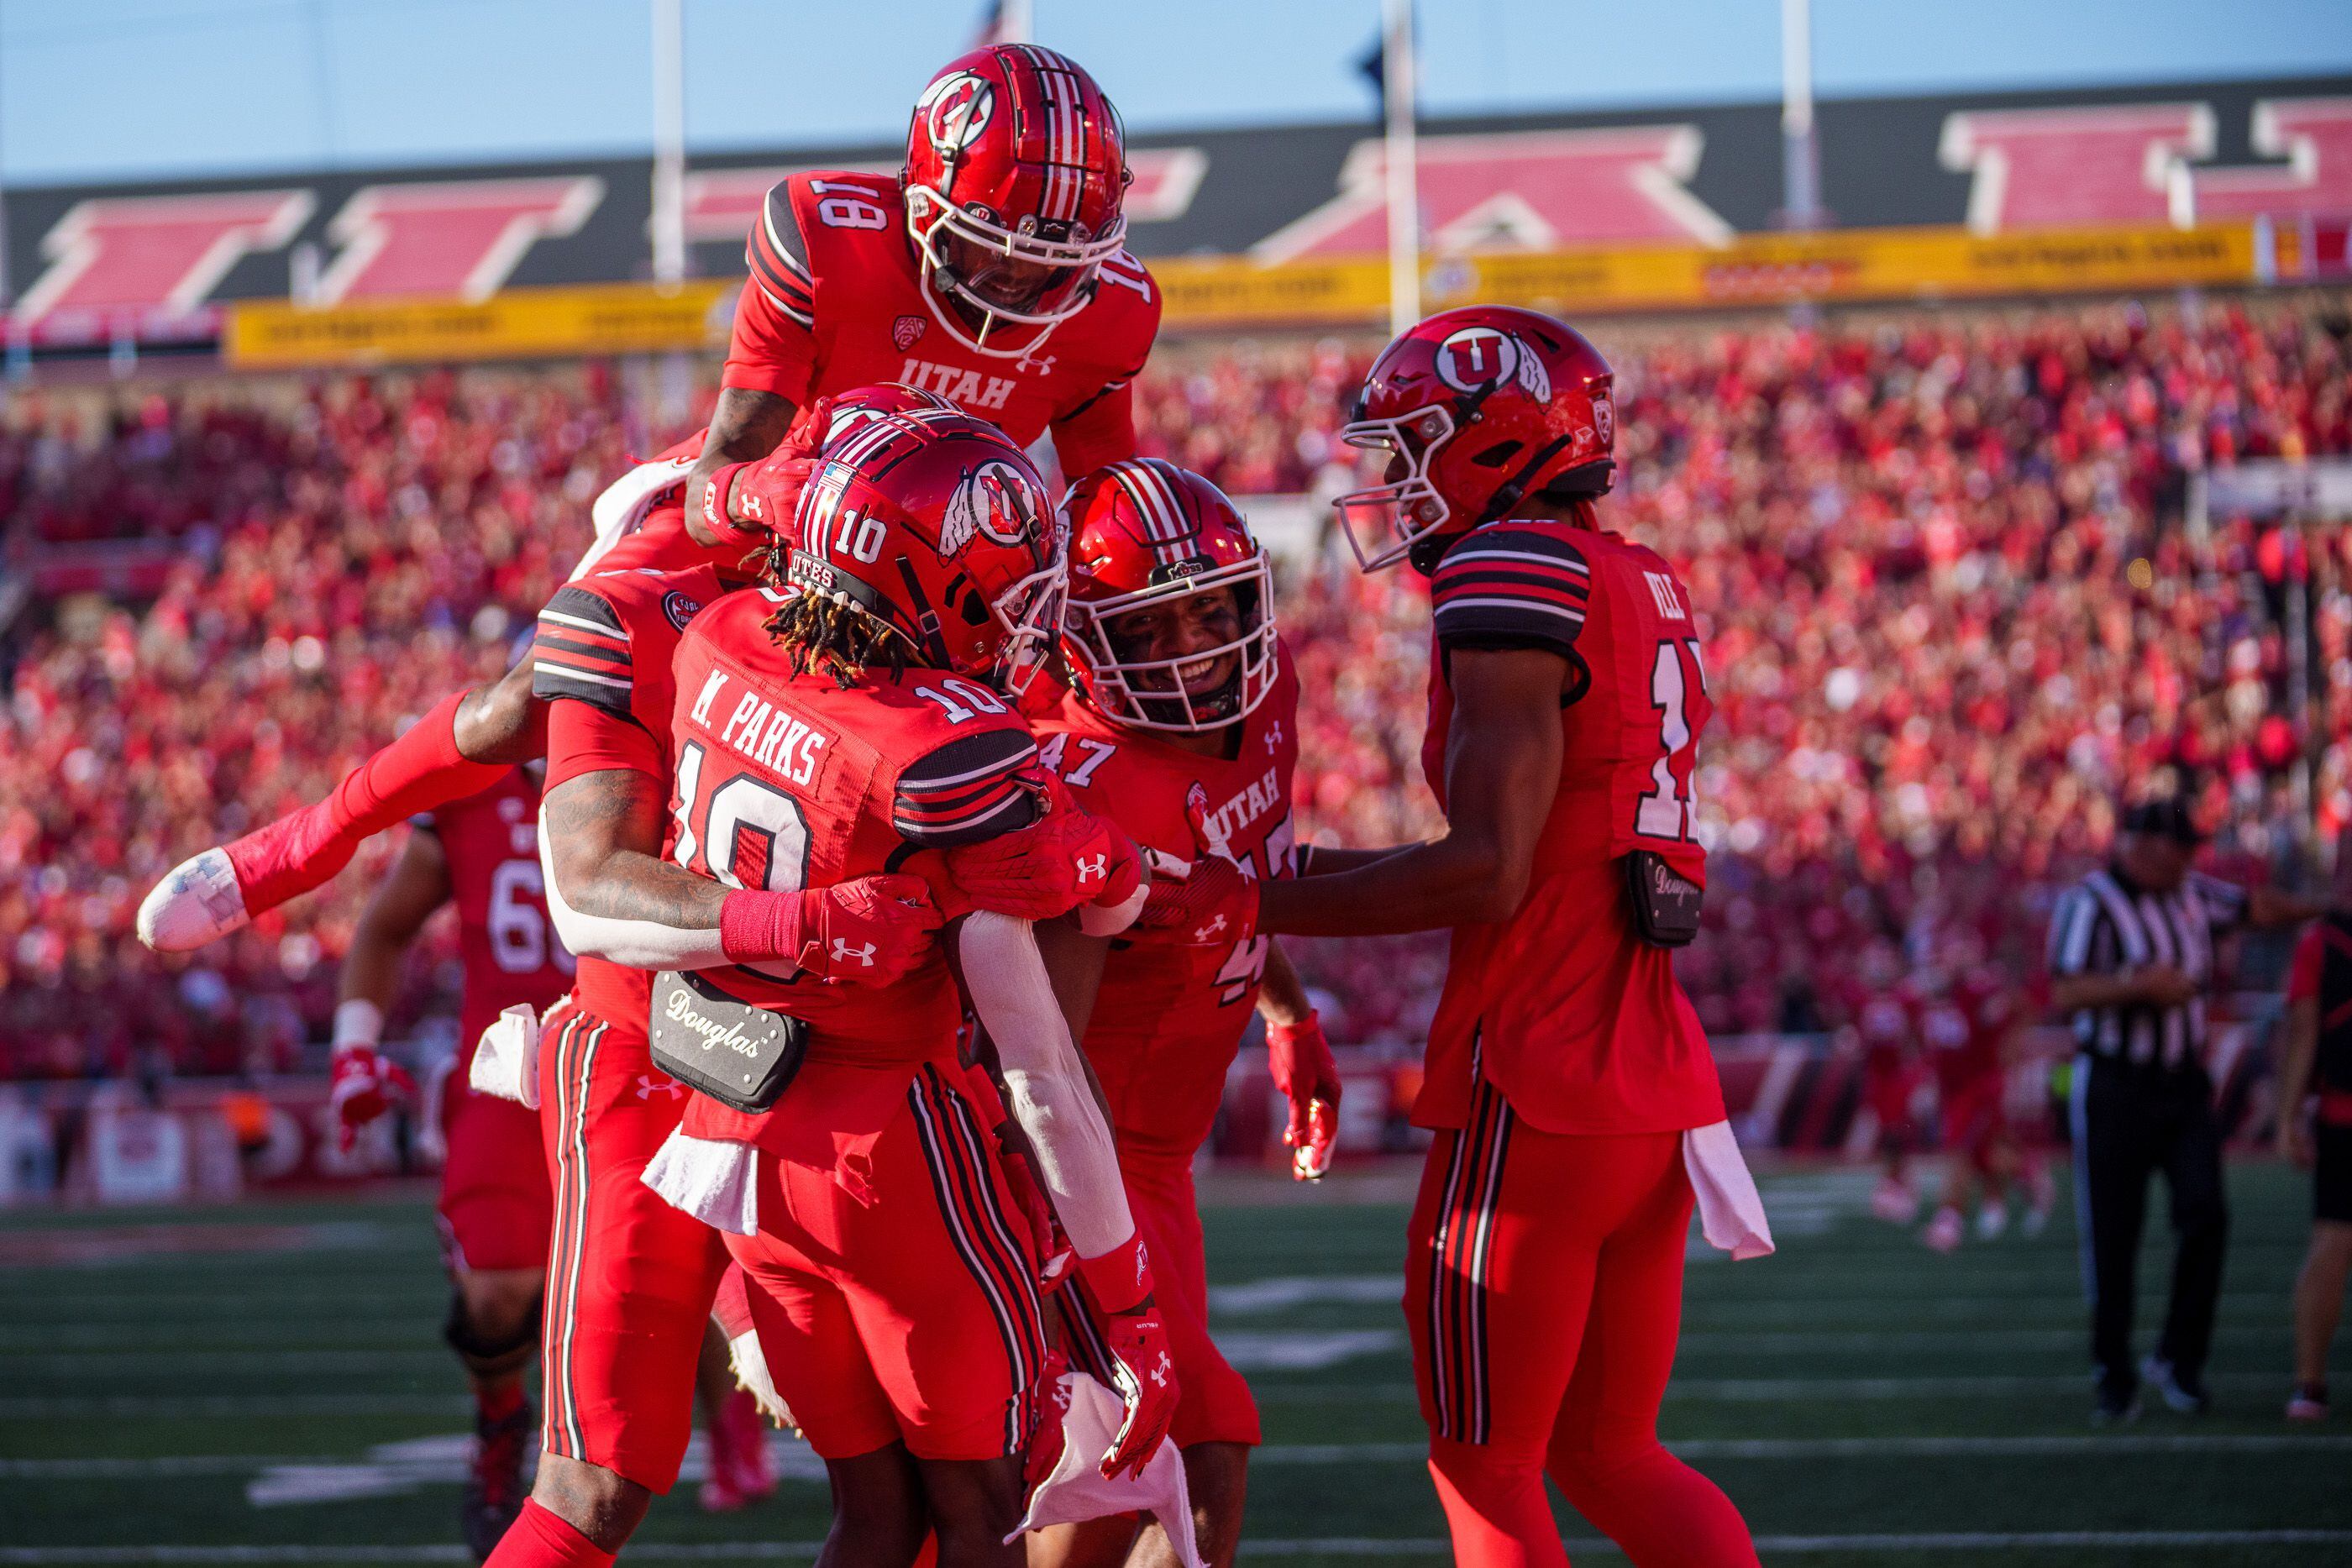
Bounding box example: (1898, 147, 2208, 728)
(899, 45, 1129, 359)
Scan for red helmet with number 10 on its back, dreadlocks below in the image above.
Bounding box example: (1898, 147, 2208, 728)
(785, 391, 1065, 696)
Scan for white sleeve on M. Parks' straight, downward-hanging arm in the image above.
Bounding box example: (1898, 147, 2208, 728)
(958, 910, 1136, 1258)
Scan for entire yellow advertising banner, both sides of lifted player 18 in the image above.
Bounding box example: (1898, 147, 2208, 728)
(223, 223, 2258, 369)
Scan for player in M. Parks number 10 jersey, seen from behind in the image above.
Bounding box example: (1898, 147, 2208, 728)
(649, 401, 1176, 1568)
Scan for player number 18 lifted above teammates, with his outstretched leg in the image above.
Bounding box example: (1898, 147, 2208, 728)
(139, 45, 1159, 952)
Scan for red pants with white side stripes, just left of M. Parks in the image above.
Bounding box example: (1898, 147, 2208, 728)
(538, 1001, 727, 1492)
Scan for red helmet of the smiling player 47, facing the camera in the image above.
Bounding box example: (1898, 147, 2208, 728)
(1063, 459, 1275, 733)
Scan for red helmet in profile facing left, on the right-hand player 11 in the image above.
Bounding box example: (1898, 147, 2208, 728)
(1331, 306, 1616, 571)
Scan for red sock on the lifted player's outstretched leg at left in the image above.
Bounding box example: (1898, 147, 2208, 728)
(226, 694, 506, 915)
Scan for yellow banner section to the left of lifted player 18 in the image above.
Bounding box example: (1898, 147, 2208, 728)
(221, 280, 741, 369)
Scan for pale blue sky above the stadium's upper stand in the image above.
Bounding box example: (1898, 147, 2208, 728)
(0, 0, 2352, 183)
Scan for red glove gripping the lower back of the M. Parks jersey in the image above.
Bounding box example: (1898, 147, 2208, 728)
(720, 872, 941, 985)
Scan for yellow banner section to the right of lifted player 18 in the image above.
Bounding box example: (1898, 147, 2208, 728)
(1152, 223, 2255, 329)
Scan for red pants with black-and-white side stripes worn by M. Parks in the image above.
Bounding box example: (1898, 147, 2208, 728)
(727, 1062, 1044, 1460)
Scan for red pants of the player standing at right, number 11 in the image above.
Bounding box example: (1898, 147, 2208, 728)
(1404, 1083, 1757, 1568)
